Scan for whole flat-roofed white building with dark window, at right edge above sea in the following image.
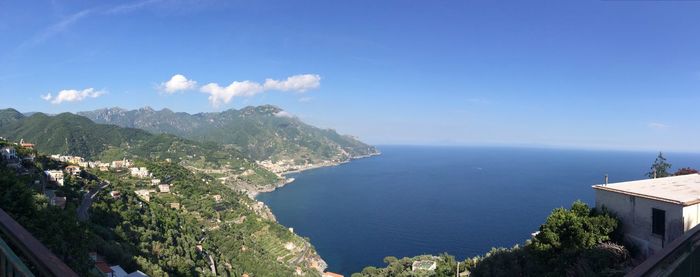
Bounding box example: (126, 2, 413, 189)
(593, 174, 700, 256)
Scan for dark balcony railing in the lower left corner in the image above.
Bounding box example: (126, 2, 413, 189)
(0, 209, 78, 277)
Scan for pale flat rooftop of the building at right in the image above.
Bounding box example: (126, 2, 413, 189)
(593, 174, 700, 206)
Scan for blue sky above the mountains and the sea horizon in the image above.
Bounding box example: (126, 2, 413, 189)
(0, 0, 700, 151)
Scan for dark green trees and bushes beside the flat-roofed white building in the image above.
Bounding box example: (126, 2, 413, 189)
(353, 201, 631, 277)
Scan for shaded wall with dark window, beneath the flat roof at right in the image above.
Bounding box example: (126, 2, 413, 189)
(595, 189, 698, 256)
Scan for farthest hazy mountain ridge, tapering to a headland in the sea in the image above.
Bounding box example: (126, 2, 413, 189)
(79, 105, 377, 164)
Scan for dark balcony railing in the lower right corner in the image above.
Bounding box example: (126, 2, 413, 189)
(627, 222, 700, 277)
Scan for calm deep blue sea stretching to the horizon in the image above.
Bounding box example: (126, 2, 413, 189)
(258, 146, 700, 276)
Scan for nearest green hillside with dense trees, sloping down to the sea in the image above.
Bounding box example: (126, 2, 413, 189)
(0, 141, 319, 276)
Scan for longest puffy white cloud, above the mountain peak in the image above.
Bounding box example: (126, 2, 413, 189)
(199, 74, 321, 107)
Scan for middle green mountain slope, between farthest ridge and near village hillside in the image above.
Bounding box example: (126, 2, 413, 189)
(0, 110, 280, 185)
